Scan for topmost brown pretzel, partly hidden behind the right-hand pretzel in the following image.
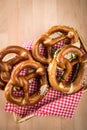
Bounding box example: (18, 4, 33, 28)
(32, 26, 78, 64)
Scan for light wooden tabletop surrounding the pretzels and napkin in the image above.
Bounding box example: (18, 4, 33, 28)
(0, 0, 87, 130)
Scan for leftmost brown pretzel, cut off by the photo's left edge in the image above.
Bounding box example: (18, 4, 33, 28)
(0, 46, 32, 90)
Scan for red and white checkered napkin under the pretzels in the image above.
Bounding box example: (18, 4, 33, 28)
(5, 40, 83, 118)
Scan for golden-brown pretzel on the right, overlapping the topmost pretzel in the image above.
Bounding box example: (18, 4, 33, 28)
(48, 45, 86, 94)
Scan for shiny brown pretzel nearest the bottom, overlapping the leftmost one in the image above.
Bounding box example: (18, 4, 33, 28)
(5, 60, 48, 106)
